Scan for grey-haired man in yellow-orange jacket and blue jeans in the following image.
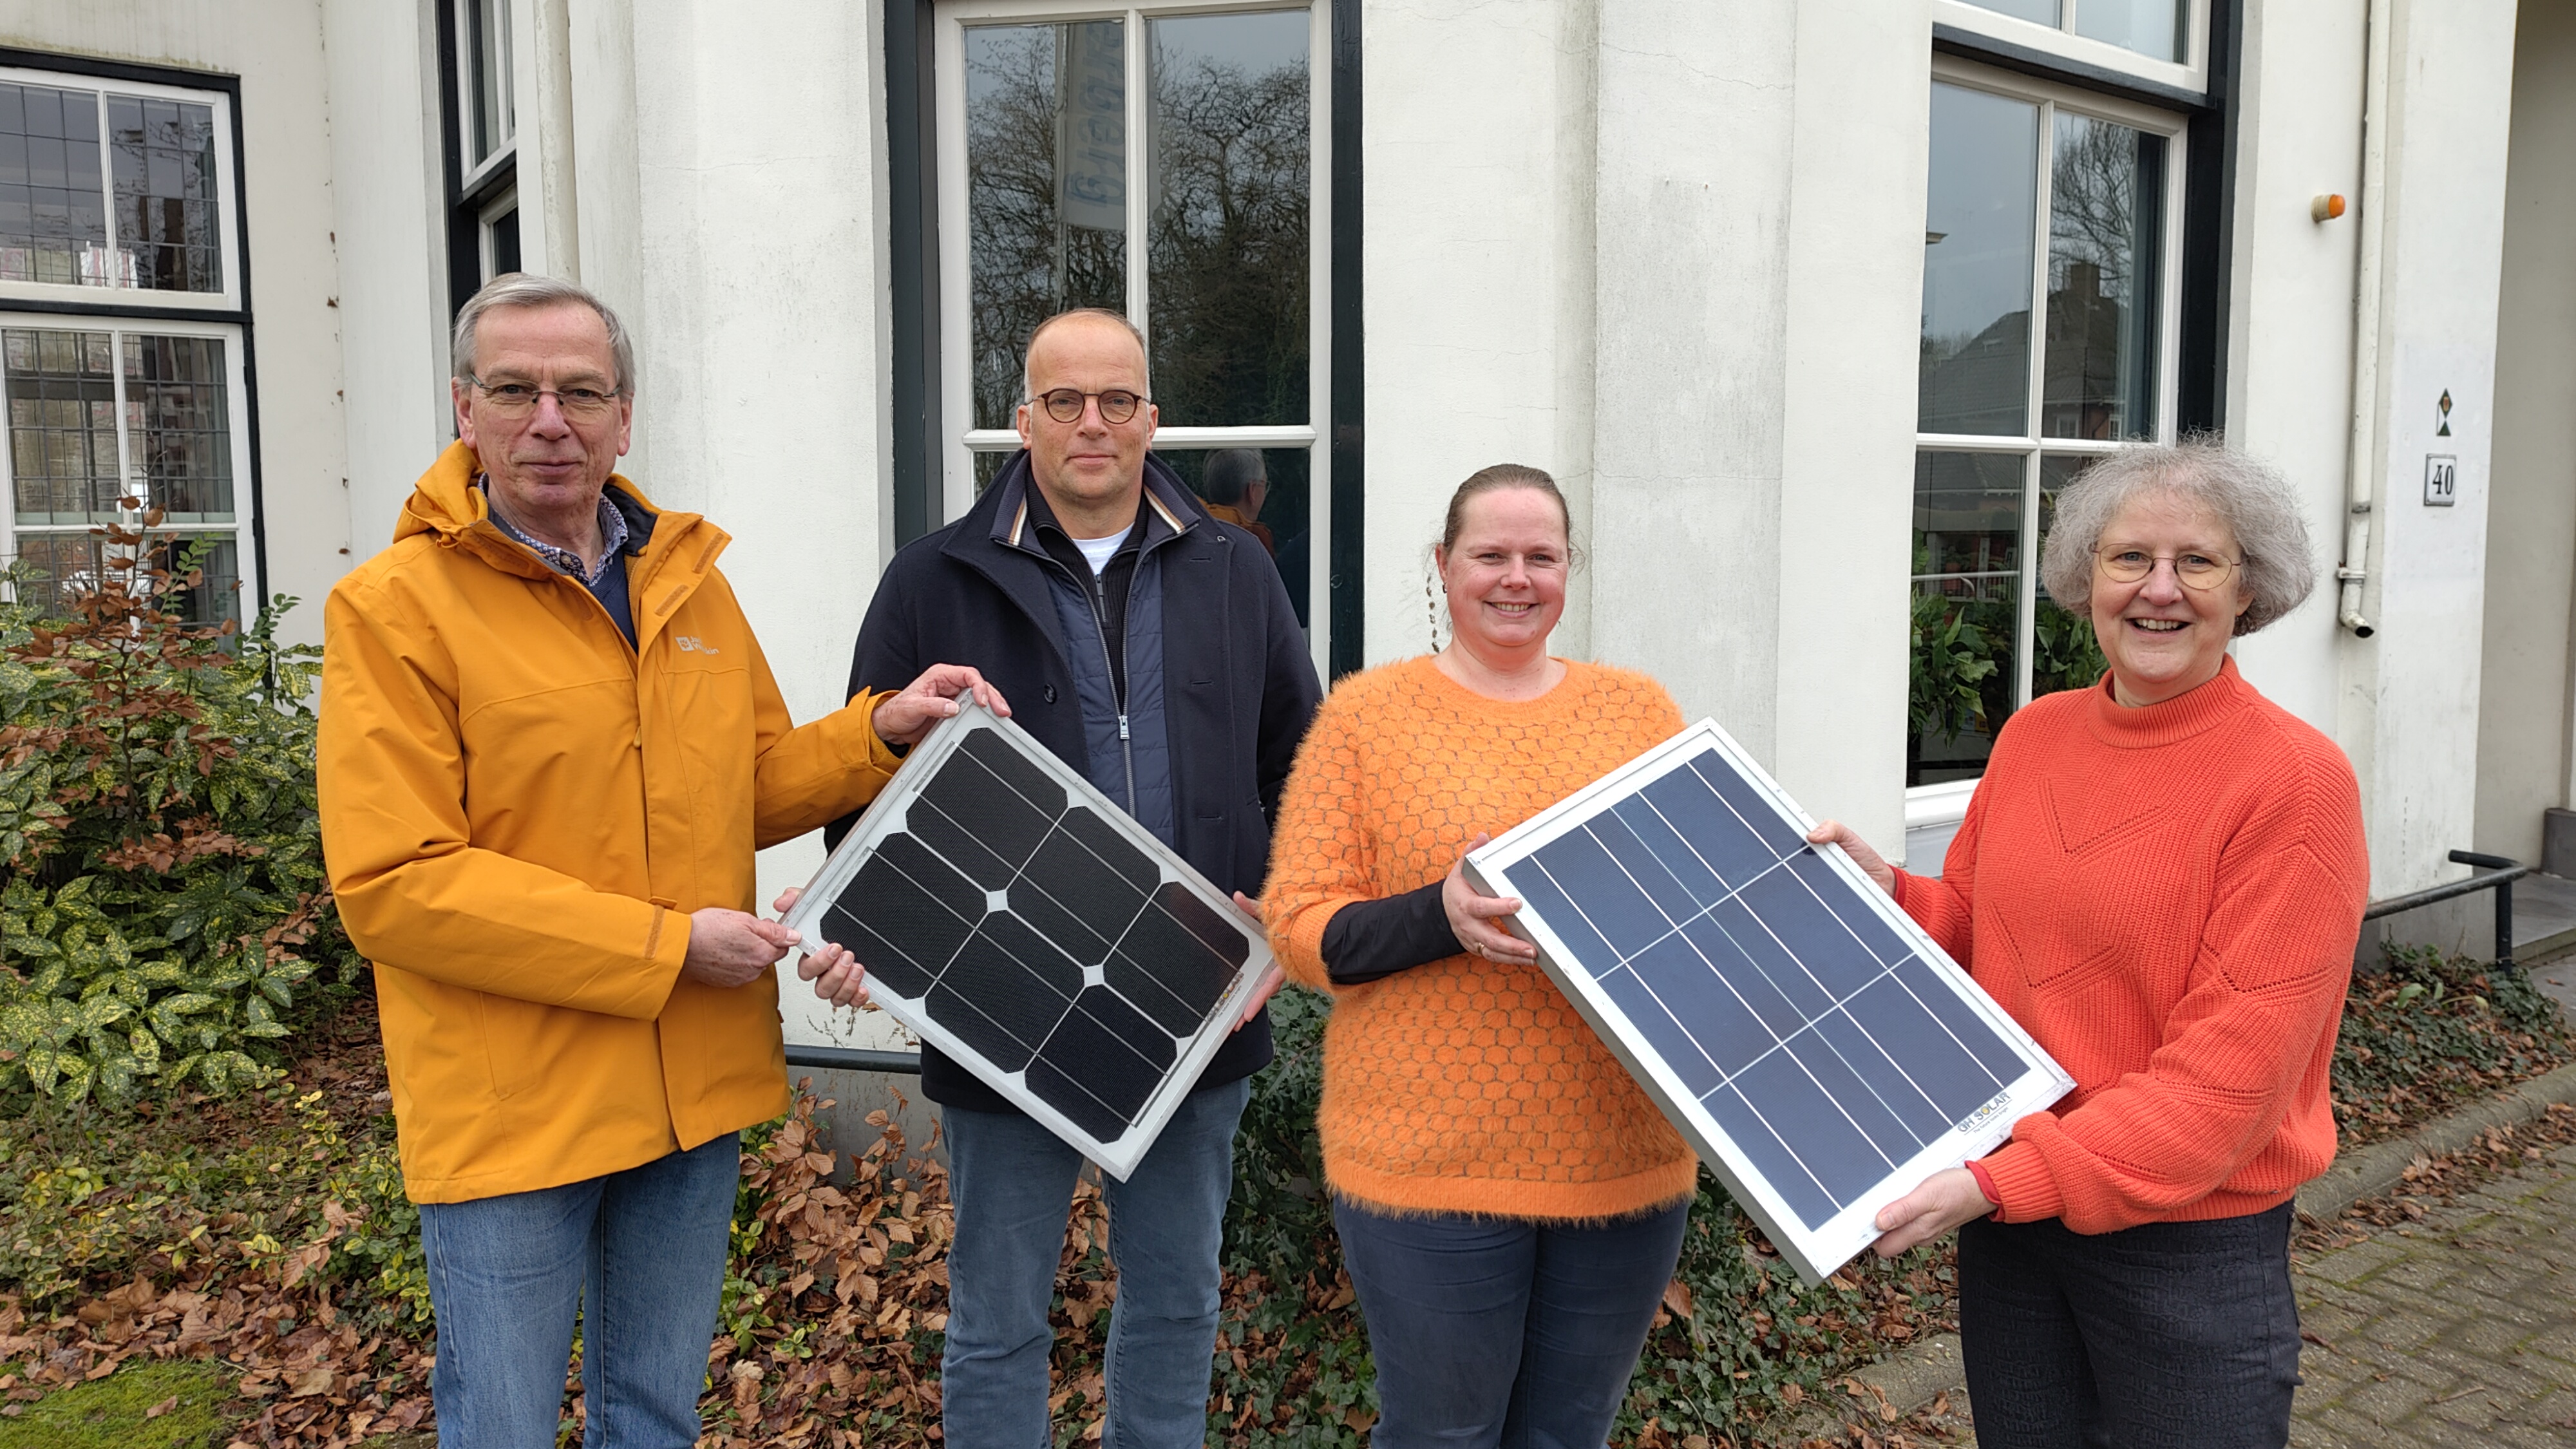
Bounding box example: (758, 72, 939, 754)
(319, 273, 999, 1449)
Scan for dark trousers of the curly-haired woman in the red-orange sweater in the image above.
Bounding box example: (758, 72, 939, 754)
(1958, 1204, 2298, 1449)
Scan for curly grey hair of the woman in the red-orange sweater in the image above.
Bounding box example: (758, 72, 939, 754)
(2040, 439, 2316, 634)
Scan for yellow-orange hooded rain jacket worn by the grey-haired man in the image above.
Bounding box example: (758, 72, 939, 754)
(319, 444, 896, 1202)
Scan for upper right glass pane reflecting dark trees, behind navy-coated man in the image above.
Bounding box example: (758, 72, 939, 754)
(1146, 10, 1314, 428)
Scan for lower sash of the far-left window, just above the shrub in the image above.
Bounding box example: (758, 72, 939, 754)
(0, 317, 245, 624)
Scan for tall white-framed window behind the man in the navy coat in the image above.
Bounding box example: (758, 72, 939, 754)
(935, 0, 1332, 668)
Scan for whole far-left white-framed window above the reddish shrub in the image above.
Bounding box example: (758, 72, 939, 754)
(0, 70, 258, 624)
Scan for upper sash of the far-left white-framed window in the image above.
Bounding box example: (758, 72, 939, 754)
(0, 70, 234, 307)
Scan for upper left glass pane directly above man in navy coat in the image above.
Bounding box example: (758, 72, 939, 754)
(966, 21, 1126, 428)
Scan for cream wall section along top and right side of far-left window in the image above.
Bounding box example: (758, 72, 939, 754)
(0, 0, 350, 639)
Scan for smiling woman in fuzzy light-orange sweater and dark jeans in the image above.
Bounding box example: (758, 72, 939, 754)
(1265, 467, 1695, 1449)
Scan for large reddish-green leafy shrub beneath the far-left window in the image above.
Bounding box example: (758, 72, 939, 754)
(0, 513, 358, 1104)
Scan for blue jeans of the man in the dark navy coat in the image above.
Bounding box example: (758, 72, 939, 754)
(940, 1080, 1252, 1449)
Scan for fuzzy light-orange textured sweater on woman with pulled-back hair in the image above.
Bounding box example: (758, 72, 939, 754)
(1265, 658, 1695, 1220)
